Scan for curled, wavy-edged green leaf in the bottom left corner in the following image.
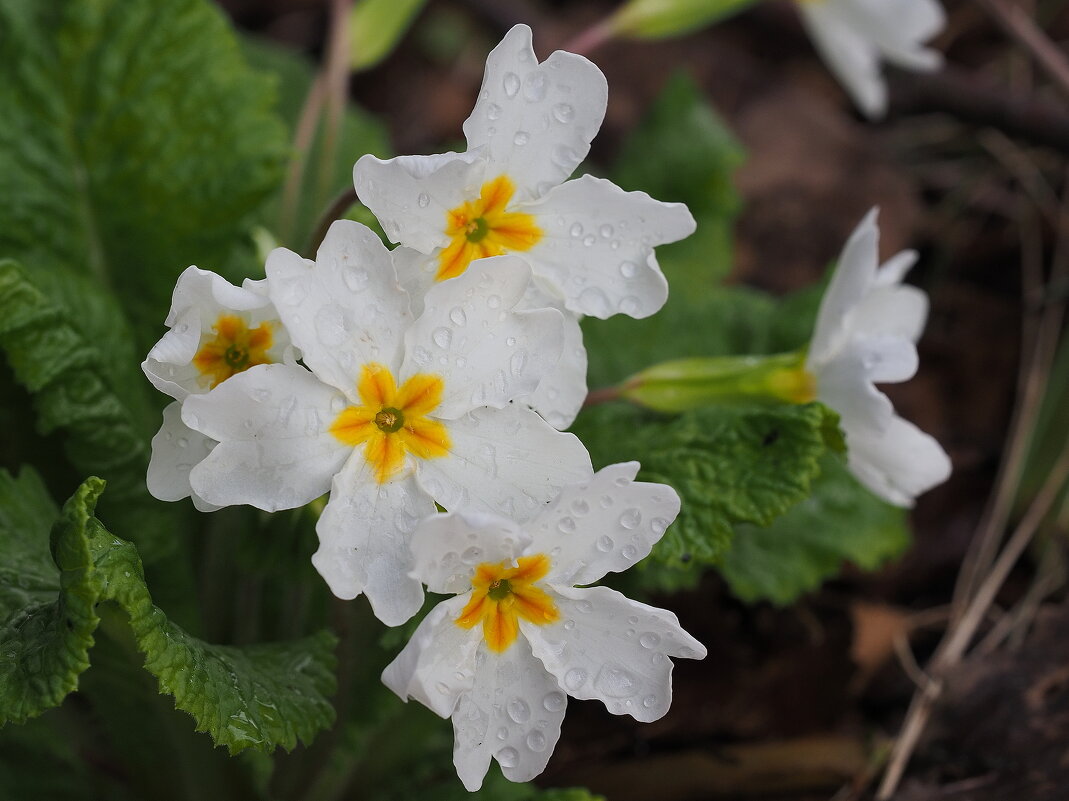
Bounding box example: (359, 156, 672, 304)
(0, 478, 336, 753)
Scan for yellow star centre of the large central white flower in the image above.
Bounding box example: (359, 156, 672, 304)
(329, 364, 450, 483)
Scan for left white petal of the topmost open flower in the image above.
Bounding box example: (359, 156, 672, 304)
(353, 151, 486, 253)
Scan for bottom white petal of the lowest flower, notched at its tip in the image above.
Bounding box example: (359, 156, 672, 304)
(452, 636, 568, 791)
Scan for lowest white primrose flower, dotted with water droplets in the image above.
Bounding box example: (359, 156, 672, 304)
(383, 462, 706, 790)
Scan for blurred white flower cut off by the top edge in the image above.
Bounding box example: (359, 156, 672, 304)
(797, 0, 946, 117)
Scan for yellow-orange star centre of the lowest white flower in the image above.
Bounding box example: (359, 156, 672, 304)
(456, 554, 560, 653)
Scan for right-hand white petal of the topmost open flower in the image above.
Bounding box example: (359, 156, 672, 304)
(517, 175, 695, 320)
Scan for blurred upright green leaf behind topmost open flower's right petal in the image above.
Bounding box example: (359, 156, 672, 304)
(613, 73, 745, 292)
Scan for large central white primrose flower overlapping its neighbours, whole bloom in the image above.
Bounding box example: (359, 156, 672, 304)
(182, 220, 592, 626)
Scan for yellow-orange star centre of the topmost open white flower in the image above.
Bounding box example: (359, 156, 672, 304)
(436, 175, 542, 281)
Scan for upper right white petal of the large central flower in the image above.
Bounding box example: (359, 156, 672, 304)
(401, 256, 564, 419)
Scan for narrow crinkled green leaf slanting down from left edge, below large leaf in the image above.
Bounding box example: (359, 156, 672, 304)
(0, 260, 181, 563)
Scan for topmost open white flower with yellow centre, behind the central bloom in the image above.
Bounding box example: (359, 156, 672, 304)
(354, 25, 695, 427)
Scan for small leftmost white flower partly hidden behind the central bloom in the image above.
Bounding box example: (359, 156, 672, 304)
(141, 267, 293, 511)
